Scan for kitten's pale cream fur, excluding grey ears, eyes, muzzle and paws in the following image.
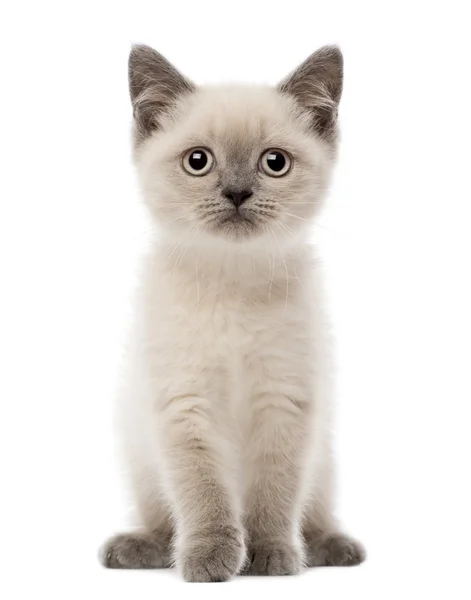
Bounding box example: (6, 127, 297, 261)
(108, 81, 354, 578)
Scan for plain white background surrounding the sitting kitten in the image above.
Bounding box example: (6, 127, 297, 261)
(0, 0, 471, 600)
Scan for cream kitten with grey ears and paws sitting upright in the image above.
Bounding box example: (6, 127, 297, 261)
(102, 46, 364, 581)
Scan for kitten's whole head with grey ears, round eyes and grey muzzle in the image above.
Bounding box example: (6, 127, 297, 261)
(129, 46, 342, 244)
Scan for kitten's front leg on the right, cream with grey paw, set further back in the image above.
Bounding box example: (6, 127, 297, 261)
(246, 360, 311, 575)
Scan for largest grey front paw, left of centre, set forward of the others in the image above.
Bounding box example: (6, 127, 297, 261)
(179, 527, 245, 582)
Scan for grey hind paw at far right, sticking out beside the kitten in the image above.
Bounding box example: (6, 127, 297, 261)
(307, 533, 366, 567)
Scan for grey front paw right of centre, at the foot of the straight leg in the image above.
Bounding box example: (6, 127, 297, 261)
(244, 540, 303, 575)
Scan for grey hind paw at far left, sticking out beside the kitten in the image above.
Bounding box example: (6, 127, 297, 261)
(100, 533, 168, 569)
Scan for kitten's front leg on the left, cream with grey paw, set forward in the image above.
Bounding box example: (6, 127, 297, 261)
(157, 390, 245, 582)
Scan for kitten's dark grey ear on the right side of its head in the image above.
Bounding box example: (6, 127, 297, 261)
(278, 46, 343, 141)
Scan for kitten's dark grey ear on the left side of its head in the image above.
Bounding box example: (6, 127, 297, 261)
(129, 45, 195, 141)
